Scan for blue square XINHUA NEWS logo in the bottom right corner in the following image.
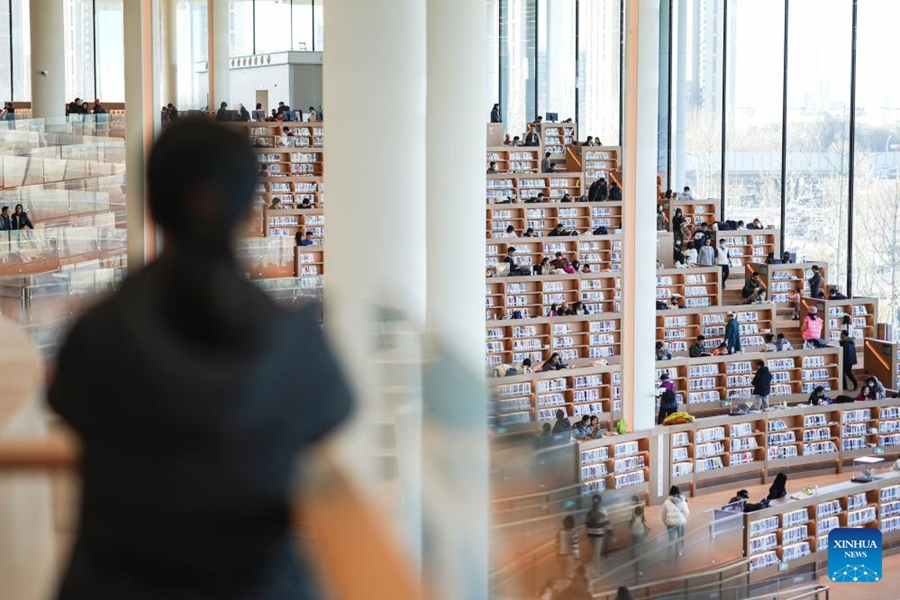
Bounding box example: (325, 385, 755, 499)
(828, 527, 882, 583)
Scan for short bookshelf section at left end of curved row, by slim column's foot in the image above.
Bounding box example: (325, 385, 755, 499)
(577, 433, 651, 495)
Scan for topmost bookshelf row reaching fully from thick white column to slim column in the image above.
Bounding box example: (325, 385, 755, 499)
(485, 202, 622, 241)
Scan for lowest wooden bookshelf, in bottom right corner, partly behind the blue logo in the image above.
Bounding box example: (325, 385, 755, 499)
(743, 473, 900, 581)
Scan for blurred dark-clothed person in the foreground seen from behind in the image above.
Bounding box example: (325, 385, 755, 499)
(50, 120, 351, 600)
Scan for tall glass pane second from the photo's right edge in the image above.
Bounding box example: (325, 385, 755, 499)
(788, 0, 852, 285)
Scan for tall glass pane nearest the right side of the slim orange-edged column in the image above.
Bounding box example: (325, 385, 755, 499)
(672, 0, 724, 198)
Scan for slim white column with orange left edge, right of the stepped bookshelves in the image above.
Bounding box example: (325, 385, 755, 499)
(622, 0, 660, 430)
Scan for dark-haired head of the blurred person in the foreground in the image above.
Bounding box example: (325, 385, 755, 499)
(147, 119, 258, 254)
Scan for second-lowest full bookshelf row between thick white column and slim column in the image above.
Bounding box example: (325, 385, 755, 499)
(485, 314, 622, 367)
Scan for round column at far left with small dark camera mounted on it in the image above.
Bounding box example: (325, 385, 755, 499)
(30, 0, 66, 119)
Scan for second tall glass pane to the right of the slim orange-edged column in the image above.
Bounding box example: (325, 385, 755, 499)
(725, 0, 784, 227)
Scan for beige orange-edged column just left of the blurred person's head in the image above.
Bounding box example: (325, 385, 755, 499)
(123, 0, 159, 273)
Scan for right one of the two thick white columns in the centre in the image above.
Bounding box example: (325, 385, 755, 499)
(426, 0, 490, 600)
